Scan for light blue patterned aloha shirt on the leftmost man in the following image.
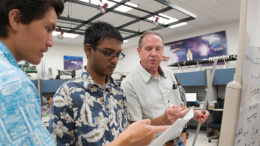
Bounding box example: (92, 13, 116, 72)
(0, 41, 55, 146)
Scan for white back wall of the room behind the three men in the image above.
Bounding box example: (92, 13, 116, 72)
(37, 21, 239, 75)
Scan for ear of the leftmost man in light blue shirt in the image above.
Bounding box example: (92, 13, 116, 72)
(8, 9, 22, 31)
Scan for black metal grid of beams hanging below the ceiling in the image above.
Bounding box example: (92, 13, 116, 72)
(62, 0, 197, 39)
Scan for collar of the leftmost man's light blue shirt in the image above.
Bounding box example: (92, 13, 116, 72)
(0, 41, 19, 68)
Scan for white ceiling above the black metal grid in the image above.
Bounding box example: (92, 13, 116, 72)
(54, 0, 240, 48)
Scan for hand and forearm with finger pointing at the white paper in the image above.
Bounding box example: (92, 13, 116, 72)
(107, 119, 169, 146)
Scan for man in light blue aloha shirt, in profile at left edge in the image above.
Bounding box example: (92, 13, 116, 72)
(0, 0, 64, 146)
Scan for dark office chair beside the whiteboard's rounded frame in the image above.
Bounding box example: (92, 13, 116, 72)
(208, 101, 224, 142)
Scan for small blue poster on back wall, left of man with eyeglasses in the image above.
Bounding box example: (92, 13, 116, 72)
(64, 56, 83, 70)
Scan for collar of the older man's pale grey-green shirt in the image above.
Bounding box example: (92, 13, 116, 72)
(137, 62, 166, 83)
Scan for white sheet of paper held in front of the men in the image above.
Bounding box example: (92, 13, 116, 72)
(149, 108, 194, 146)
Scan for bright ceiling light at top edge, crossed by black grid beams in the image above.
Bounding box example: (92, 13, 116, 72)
(80, 0, 138, 13)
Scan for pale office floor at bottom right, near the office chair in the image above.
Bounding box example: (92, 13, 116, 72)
(186, 129, 217, 146)
